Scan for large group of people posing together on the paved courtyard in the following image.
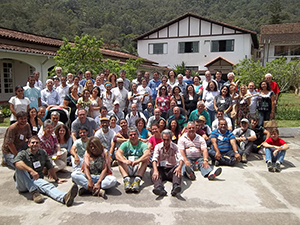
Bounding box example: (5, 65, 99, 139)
(2, 67, 289, 206)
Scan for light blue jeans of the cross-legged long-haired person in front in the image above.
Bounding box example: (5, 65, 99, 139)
(71, 170, 117, 190)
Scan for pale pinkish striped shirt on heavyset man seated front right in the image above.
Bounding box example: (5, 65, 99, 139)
(178, 133, 207, 159)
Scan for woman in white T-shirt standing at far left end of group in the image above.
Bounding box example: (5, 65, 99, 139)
(8, 85, 30, 125)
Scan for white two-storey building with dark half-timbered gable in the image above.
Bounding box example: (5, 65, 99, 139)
(135, 13, 258, 74)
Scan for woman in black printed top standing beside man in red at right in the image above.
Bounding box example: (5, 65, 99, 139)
(257, 80, 275, 126)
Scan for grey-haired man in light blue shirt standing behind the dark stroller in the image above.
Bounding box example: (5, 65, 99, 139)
(41, 79, 60, 107)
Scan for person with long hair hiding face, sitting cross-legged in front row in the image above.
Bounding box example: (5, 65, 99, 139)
(71, 137, 117, 198)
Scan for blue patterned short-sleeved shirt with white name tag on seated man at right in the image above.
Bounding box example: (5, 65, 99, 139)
(210, 129, 235, 152)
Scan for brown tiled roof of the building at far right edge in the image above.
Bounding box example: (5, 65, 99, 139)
(260, 23, 300, 44)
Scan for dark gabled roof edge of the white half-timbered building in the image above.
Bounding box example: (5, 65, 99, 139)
(133, 12, 258, 47)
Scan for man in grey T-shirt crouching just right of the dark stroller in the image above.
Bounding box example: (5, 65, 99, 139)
(71, 108, 99, 142)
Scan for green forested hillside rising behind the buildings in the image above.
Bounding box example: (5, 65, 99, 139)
(0, 0, 300, 53)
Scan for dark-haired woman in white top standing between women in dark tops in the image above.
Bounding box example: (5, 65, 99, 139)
(203, 81, 219, 122)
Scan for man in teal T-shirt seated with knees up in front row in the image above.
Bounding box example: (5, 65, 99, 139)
(116, 128, 150, 193)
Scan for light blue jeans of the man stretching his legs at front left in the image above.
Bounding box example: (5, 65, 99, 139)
(15, 169, 66, 203)
